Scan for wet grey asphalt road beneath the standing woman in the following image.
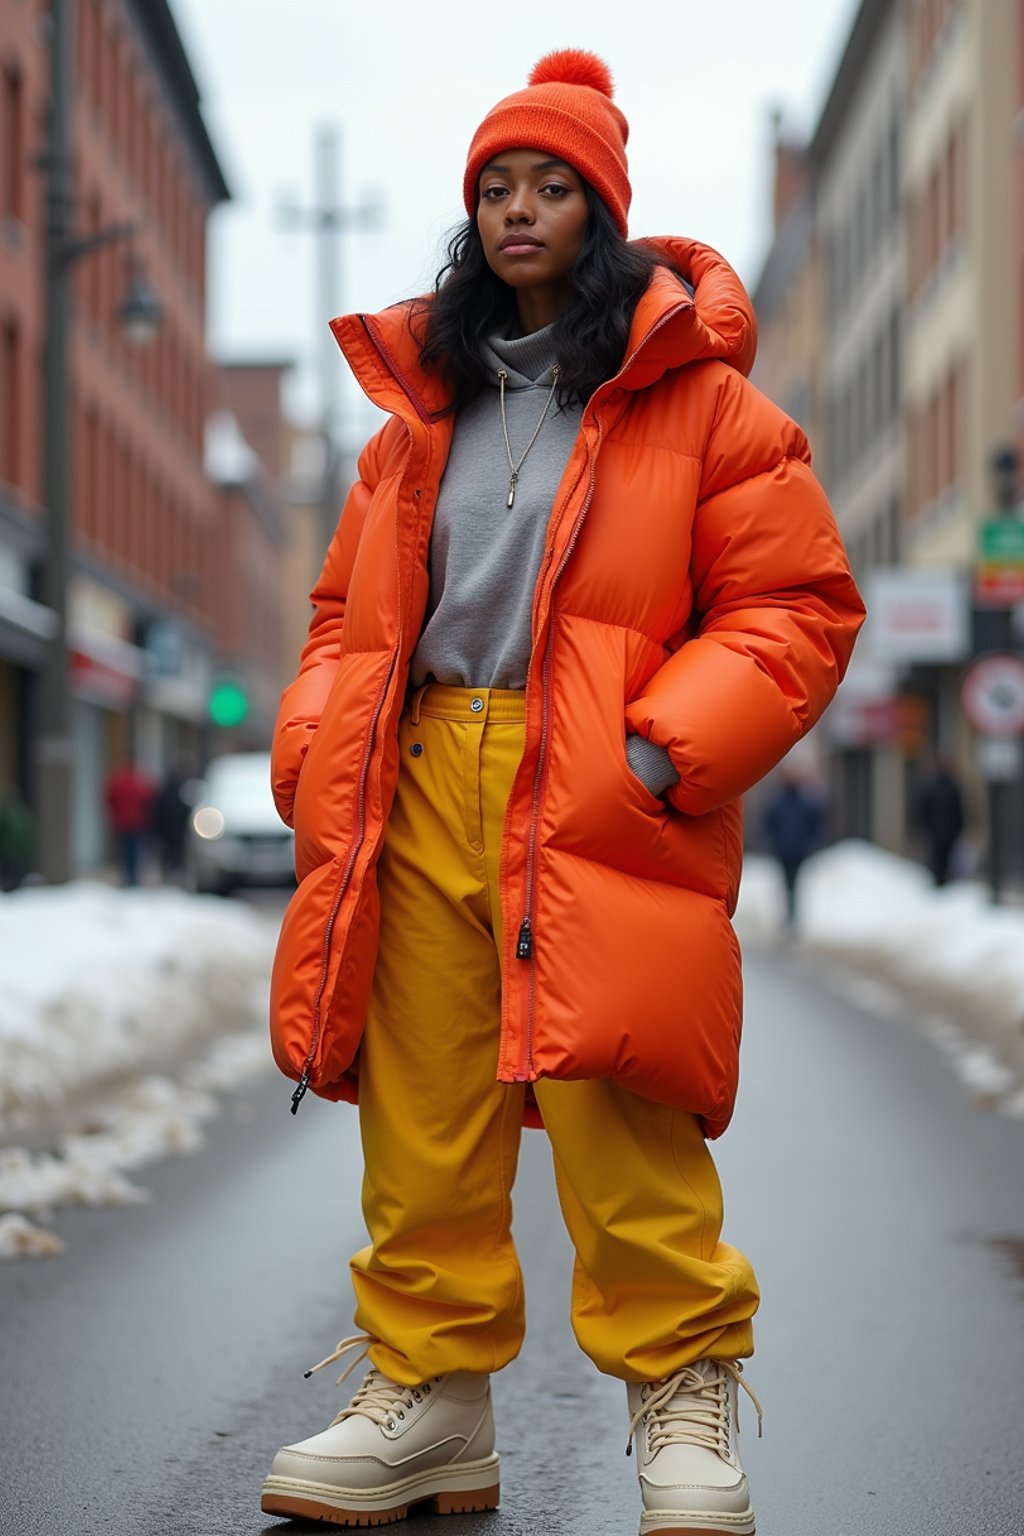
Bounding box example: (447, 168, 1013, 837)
(0, 933, 1024, 1536)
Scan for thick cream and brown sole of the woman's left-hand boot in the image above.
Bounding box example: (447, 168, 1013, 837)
(259, 1456, 499, 1527)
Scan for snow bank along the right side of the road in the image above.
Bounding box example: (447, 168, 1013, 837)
(737, 840, 1024, 1095)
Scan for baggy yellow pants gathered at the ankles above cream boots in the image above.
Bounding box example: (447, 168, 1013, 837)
(352, 687, 758, 1384)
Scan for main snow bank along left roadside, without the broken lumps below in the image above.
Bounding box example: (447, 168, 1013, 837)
(0, 882, 273, 1141)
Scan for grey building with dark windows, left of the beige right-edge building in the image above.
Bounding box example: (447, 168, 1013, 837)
(808, 0, 906, 846)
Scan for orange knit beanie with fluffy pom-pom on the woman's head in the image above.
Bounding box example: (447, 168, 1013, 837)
(462, 48, 633, 235)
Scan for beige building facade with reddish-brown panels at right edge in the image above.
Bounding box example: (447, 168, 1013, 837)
(903, 0, 1019, 571)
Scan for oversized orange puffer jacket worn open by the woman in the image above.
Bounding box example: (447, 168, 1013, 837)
(272, 241, 863, 1137)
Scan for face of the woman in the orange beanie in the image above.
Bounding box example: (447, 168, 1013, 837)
(476, 149, 588, 324)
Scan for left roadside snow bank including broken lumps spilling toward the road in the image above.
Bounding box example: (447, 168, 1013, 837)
(0, 883, 273, 1258)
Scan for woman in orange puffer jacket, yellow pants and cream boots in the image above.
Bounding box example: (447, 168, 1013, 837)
(263, 52, 861, 1533)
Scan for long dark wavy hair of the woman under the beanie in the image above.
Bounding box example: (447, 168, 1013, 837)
(419, 181, 659, 412)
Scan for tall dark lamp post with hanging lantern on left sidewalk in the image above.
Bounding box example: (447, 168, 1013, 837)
(35, 0, 160, 883)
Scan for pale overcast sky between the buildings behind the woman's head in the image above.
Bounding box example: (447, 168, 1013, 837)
(170, 0, 858, 436)
